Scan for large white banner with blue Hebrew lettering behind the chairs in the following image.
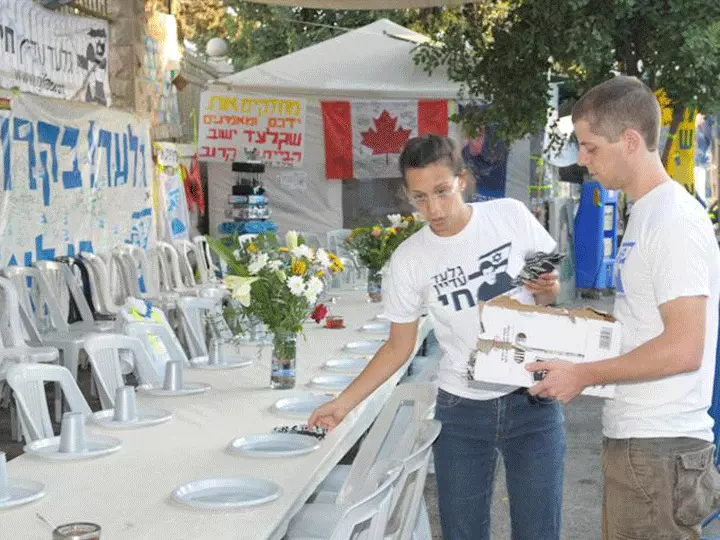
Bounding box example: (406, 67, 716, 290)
(0, 94, 156, 267)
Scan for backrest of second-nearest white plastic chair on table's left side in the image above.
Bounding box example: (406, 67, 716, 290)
(85, 333, 148, 409)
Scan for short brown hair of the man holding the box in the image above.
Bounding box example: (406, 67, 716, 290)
(572, 75, 661, 152)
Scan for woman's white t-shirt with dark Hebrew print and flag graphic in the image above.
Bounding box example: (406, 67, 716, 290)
(383, 199, 555, 400)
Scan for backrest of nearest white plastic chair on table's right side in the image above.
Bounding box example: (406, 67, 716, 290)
(330, 462, 402, 540)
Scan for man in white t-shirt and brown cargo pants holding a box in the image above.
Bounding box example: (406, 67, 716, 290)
(529, 77, 720, 540)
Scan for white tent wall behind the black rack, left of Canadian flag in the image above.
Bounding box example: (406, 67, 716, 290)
(208, 96, 343, 236)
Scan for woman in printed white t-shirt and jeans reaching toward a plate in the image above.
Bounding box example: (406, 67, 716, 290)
(309, 135, 565, 540)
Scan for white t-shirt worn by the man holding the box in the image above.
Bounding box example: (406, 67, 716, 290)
(603, 181, 720, 441)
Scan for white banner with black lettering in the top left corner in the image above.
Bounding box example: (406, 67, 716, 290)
(0, 0, 110, 105)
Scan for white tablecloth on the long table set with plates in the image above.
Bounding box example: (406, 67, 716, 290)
(0, 292, 429, 540)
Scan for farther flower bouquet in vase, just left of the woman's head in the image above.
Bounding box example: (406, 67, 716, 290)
(345, 214, 425, 302)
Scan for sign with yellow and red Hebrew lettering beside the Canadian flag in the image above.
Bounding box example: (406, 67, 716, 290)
(198, 90, 305, 167)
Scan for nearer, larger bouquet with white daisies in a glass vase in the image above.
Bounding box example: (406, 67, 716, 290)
(208, 231, 344, 388)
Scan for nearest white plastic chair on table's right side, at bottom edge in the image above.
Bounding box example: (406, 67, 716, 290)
(286, 462, 402, 540)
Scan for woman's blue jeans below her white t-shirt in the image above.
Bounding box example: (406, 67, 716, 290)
(433, 390, 565, 540)
